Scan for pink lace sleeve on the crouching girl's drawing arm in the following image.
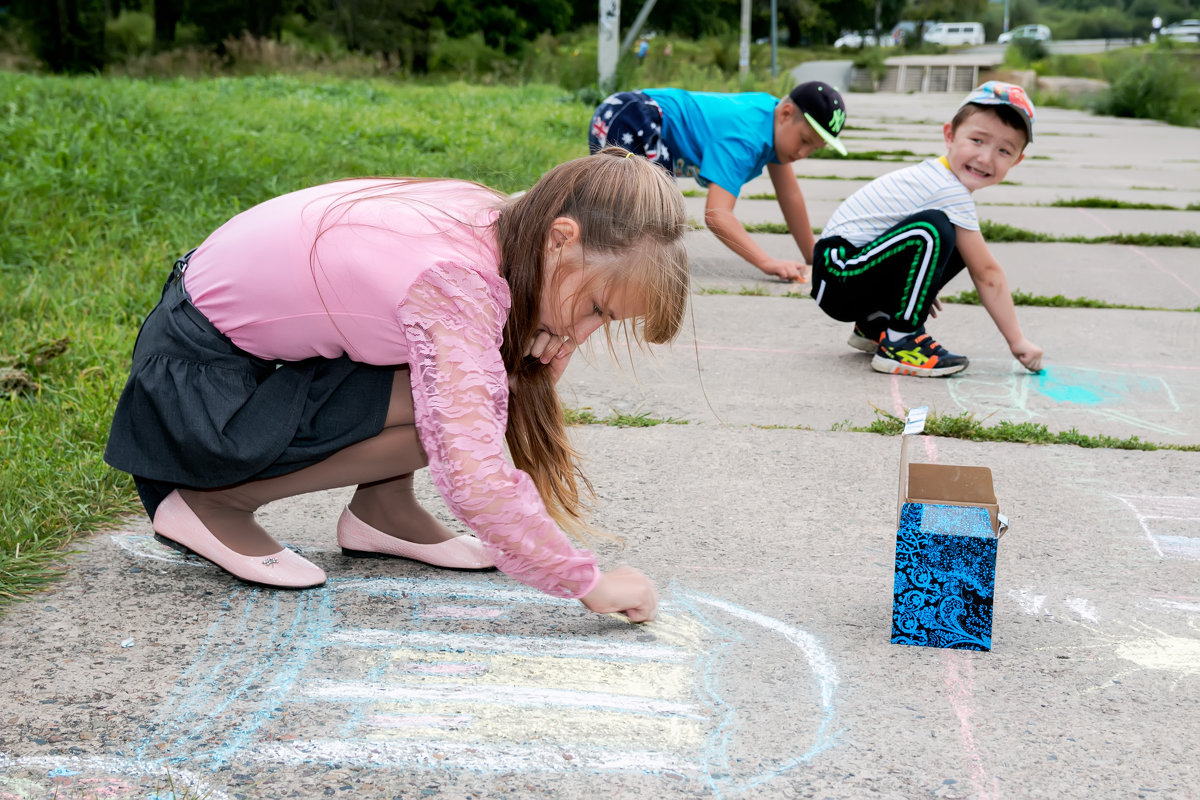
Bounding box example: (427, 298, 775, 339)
(397, 263, 600, 597)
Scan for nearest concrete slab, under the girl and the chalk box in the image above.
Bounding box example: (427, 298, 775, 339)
(0, 426, 1200, 800)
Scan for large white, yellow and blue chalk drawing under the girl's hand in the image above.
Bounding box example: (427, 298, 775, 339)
(63, 544, 839, 796)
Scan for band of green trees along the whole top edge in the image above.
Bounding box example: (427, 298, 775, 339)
(0, 0, 1180, 74)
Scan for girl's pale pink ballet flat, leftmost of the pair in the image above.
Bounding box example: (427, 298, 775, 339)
(154, 492, 325, 589)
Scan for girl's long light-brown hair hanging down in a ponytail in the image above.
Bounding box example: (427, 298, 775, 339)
(496, 148, 689, 542)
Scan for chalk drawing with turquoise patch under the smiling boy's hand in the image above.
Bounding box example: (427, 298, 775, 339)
(947, 365, 1184, 435)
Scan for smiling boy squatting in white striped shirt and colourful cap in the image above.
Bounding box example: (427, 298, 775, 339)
(812, 80, 1042, 378)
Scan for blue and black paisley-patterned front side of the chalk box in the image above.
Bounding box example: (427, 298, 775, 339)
(892, 503, 1000, 650)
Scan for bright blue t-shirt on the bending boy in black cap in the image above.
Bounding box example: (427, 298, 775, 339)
(644, 89, 779, 197)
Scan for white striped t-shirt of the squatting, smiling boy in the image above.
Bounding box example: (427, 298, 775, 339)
(821, 158, 979, 247)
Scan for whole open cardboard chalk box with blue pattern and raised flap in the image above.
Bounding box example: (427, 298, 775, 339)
(892, 408, 1008, 650)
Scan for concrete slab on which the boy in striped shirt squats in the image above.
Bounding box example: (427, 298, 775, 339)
(562, 295, 1200, 445)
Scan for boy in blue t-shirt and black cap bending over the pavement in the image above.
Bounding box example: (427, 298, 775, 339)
(588, 80, 846, 283)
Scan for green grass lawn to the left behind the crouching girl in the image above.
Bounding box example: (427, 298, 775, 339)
(0, 72, 590, 602)
